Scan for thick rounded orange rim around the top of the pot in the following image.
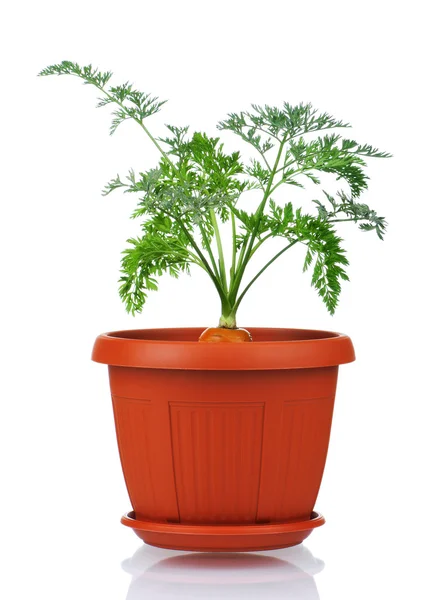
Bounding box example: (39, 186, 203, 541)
(92, 327, 355, 371)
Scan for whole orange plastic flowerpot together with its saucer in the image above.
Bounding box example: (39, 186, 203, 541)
(92, 328, 354, 551)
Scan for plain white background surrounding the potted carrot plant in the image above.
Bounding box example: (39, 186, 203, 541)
(0, 0, 444, 600)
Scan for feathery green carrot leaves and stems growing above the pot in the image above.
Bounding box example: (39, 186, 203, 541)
(39, 61, 390, 329)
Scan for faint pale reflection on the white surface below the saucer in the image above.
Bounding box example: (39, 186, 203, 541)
(122, 545, 324, 600)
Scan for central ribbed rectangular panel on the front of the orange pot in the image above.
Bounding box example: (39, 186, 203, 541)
(169, 401, 264, 523)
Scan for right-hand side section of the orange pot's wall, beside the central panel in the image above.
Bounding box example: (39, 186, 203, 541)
(256, 367, 338, 523)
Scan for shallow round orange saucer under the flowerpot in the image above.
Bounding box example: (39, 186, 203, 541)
(121, 511, 325, 552)
